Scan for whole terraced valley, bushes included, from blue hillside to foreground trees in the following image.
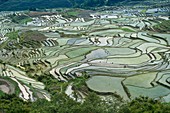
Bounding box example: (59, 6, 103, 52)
(0, 0, 170, 113)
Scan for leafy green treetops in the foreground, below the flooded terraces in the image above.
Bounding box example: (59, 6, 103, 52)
(0, 93, 170, 113)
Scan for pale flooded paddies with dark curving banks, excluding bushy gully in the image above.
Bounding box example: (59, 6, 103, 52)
(0, 10, 170, 102)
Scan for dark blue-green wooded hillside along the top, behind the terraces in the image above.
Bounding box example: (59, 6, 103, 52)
(0, 0, 144, 11)
